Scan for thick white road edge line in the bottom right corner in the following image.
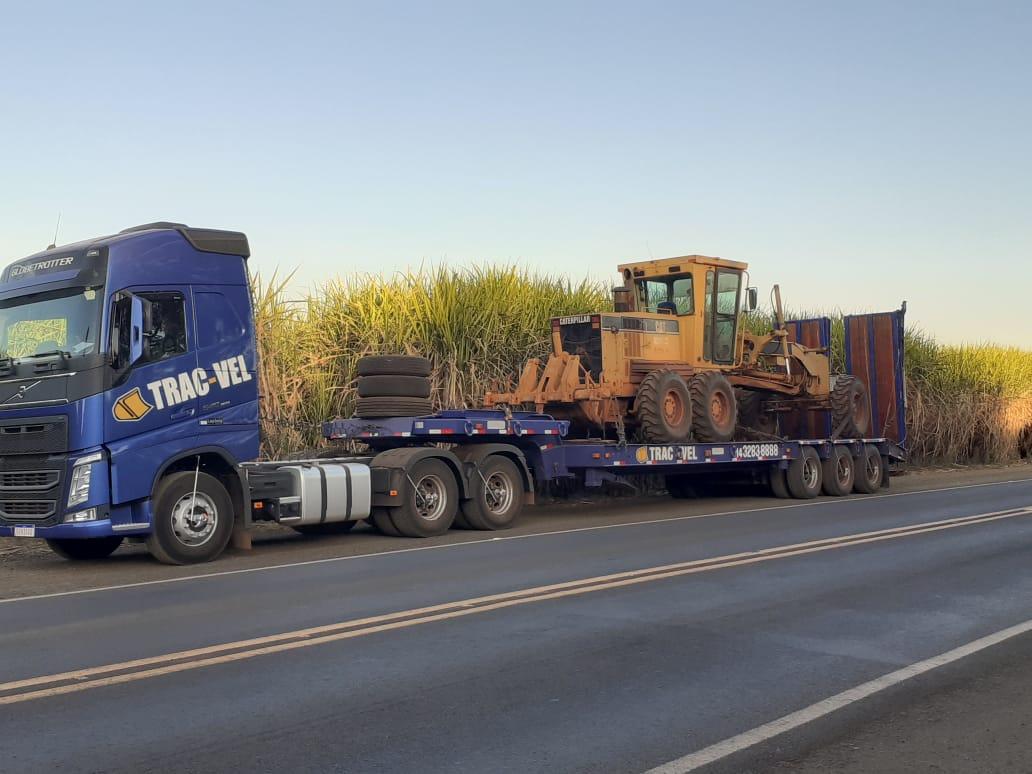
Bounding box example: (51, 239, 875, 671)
(646, 620, 1032, 774)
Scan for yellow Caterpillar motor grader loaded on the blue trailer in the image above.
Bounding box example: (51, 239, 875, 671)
(484, 255, 871, 444)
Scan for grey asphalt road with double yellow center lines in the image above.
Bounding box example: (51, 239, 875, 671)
(0, 473, 1032, 773)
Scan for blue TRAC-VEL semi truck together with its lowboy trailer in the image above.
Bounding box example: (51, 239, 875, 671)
(0, 222, 904, 563)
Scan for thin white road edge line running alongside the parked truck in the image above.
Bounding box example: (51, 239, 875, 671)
(0, 479, 1032, 605)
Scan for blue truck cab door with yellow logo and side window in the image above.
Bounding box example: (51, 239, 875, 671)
(104, 286, 199, 502)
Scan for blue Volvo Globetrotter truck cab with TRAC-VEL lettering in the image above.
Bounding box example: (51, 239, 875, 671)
(0, 223, 259, 561)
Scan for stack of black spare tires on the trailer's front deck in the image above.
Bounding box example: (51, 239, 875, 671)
(355, 355, 433, 419)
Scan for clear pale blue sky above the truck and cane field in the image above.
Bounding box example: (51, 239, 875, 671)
(0, 0, 1032, 346)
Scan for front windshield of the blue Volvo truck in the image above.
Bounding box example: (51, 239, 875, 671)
(0, 287, 104, 360)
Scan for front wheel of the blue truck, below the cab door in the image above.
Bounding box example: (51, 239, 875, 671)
(147, 472, 234, 565)
